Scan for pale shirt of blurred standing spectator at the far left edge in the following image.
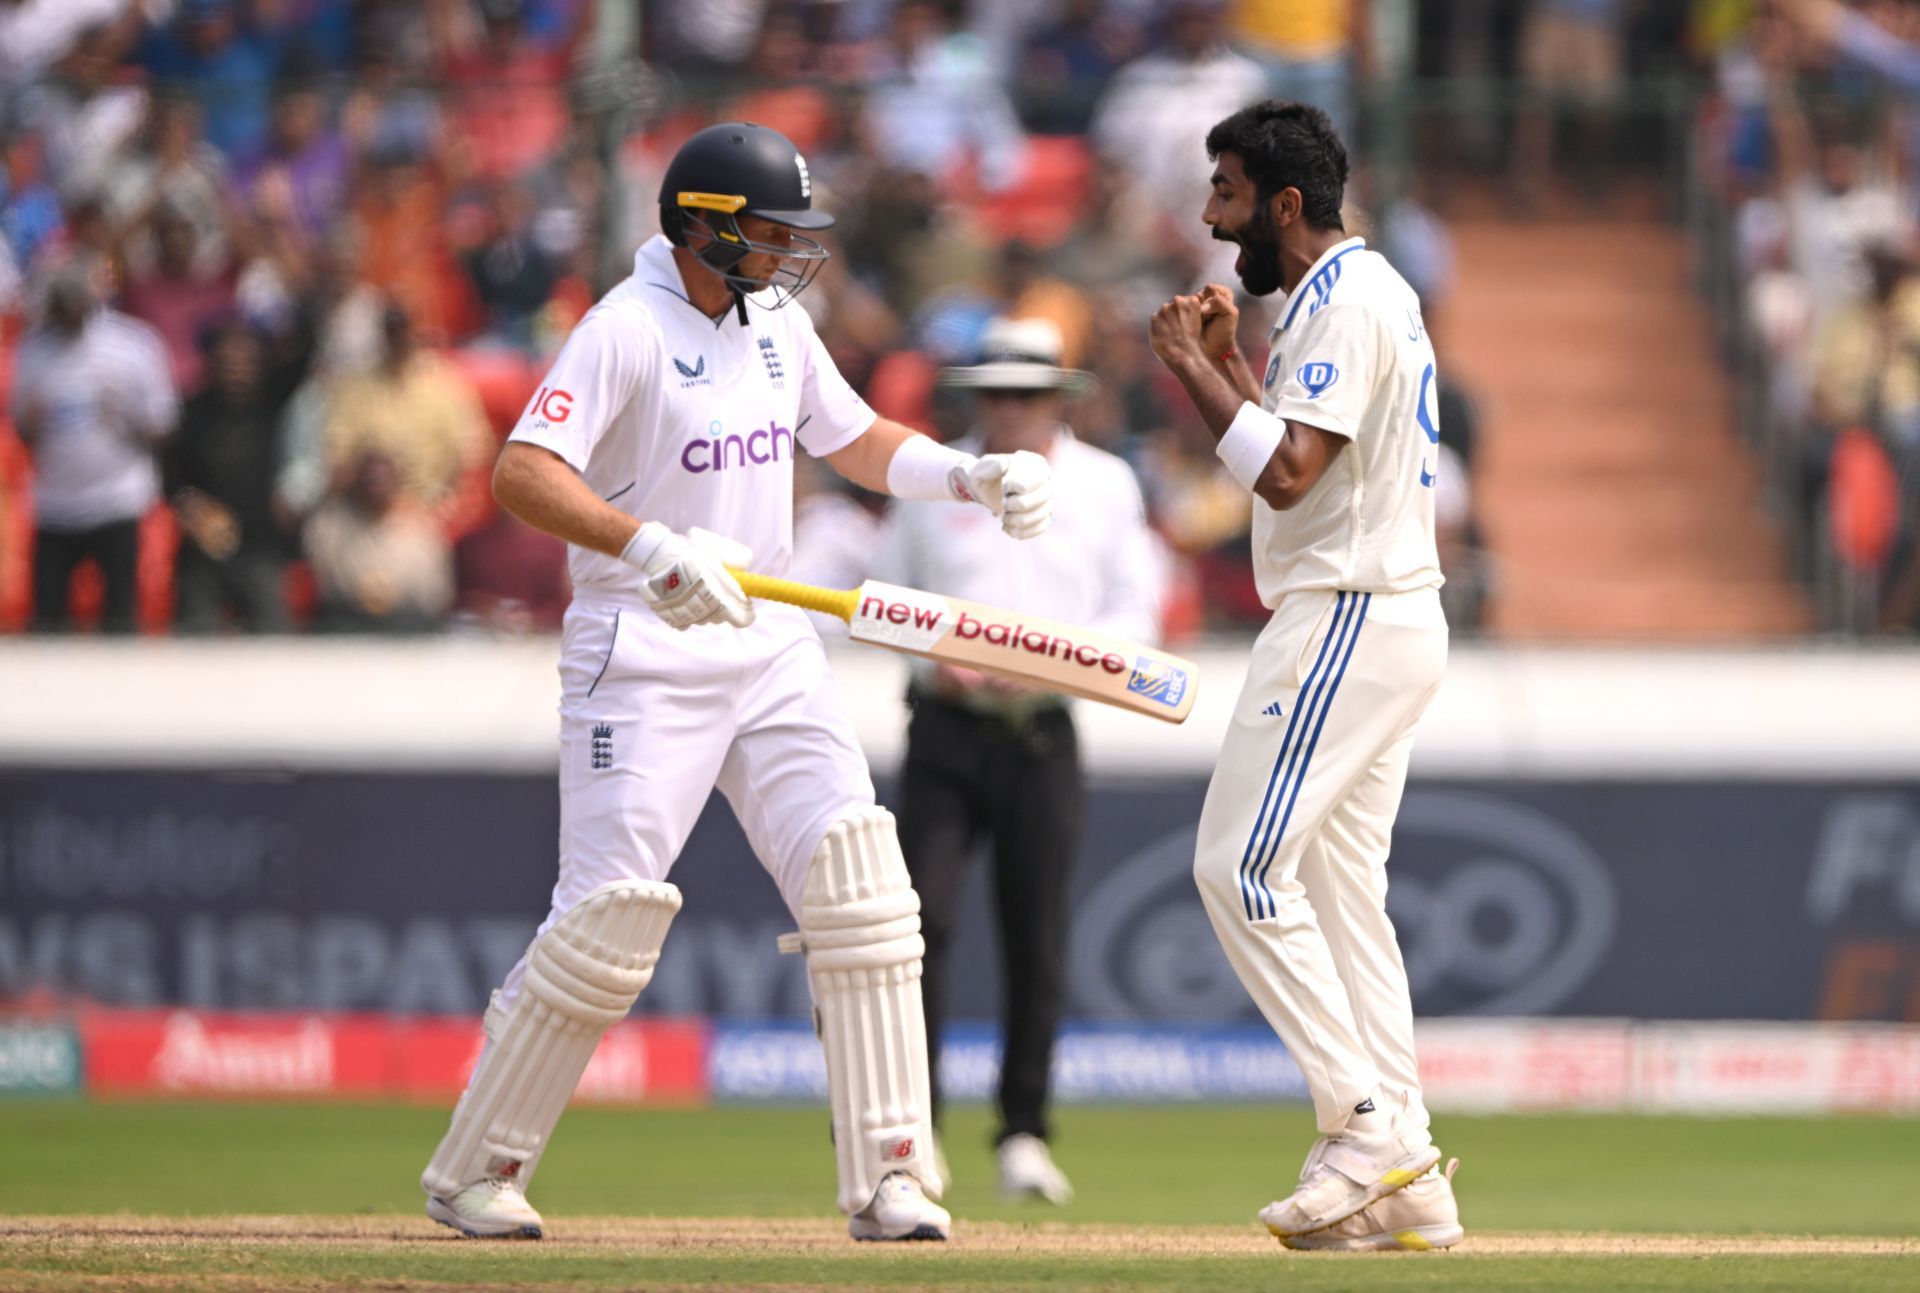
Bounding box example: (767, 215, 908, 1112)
(13, 309, 179, 530)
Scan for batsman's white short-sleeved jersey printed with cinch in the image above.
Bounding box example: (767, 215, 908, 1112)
(511, 234, 876, 599)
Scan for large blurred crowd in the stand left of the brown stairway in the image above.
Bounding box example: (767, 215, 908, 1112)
(0, 0, 1497, 638)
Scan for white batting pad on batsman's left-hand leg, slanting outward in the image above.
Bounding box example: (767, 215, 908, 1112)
(420, 880, 680, 1199)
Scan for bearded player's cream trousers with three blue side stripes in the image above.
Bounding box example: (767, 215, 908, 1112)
(1194, 590, 1448, 1135)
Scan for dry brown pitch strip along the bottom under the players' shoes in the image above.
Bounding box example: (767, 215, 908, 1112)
(0, 1214, 1920, 1293)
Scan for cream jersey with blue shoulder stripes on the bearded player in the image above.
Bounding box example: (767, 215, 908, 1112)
(1254, 238, 1442, 607)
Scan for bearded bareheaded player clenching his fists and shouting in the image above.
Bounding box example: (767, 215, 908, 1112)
(1150, 100, 1461, 1249)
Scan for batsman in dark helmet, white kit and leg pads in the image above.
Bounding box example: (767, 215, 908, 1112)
(420, 121, 1050, 1239)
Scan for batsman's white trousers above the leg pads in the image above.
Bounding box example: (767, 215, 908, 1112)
(497, 599, 874, 1009)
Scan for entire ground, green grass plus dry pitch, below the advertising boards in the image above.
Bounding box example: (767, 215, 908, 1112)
(0, 1103, 1920, 1293)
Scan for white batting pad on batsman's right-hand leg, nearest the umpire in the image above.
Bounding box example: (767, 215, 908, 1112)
(801, 807, 941, 1214)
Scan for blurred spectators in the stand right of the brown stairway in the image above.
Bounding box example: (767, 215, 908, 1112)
(1703, 0, 1920, 634)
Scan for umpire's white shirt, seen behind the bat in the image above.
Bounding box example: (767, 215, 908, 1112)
(874, 427, 1164, 683)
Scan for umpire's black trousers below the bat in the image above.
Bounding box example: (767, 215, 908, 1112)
(900, 694, 1083, 1139)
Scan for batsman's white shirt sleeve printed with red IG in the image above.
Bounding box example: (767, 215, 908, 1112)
(507, 309, 657, 473)
